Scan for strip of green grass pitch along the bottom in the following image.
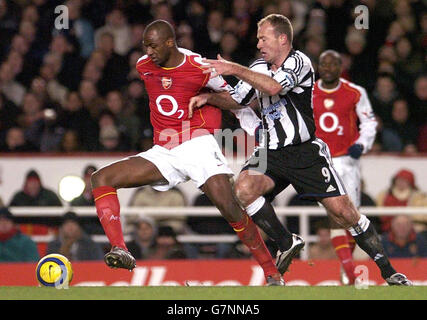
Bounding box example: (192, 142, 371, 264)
(0, 286, 427, 300)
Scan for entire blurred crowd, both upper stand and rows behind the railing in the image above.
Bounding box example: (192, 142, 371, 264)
(0, 0, 427, 262)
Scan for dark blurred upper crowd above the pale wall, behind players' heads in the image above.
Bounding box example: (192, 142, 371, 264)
(0, 0, 427, 154)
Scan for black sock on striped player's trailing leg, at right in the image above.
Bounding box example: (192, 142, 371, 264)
(353, 223, 396, 279)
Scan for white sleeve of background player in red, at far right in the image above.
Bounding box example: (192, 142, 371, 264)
(356, 87, 377, 153)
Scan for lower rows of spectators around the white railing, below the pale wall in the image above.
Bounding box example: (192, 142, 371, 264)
(0, 164, 427, 262)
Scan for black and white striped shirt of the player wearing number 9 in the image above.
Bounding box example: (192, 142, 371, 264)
(230, 49, 315, 149)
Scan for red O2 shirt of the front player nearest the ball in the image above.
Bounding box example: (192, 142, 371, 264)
(136, 49, 229, 149)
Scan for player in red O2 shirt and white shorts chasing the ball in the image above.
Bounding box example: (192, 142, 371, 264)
(91, 20, 283, 285)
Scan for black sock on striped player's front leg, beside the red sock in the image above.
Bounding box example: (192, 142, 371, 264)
(251, 200, 293, 251)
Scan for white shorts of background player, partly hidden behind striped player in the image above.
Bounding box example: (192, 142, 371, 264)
(332, 156, 362, 208)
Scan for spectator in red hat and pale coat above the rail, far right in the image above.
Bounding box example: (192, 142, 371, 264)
(377, 169, 427, 232)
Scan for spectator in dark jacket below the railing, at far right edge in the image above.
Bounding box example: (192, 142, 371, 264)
(382, 215, 427, 258)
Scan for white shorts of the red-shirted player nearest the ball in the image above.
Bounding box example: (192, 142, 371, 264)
(137, 134, 233, 191)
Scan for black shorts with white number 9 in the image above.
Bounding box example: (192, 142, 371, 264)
(242, 139, 346, 201)
